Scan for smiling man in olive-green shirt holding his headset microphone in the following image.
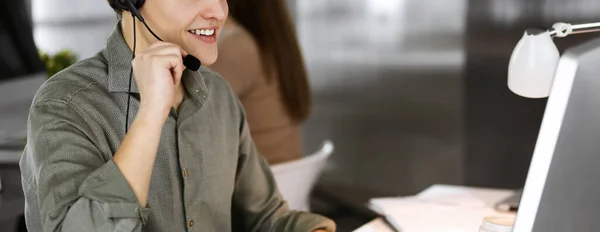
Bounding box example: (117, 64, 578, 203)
(20, 0, 335, 232)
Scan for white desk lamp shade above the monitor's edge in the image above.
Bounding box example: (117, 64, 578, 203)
(508, 29, 560, 98)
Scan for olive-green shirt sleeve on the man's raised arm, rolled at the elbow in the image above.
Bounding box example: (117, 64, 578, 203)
(20, 101, 148, 232)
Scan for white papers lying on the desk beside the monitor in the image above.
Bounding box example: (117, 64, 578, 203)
(370, 185, 512, 232)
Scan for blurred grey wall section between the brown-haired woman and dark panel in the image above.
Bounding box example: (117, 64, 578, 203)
(298, 0, 466, 196)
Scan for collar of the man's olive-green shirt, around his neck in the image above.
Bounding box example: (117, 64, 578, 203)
(103, 21, 208, 105)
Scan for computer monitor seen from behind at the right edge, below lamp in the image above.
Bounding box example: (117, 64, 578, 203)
(513, 35, 600, 232)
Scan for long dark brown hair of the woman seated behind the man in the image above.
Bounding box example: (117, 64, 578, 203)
(227, 0, 311, 122)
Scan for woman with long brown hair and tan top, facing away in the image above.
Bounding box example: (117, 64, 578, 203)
(210, 0, 310, 164)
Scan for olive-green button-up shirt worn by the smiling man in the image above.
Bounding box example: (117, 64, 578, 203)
(20, 24, 335, 232)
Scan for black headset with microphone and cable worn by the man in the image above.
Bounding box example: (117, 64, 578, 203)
(111, 0, 201, 134)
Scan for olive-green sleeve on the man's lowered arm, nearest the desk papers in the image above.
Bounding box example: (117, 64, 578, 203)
(233, 103, 336, 232)
